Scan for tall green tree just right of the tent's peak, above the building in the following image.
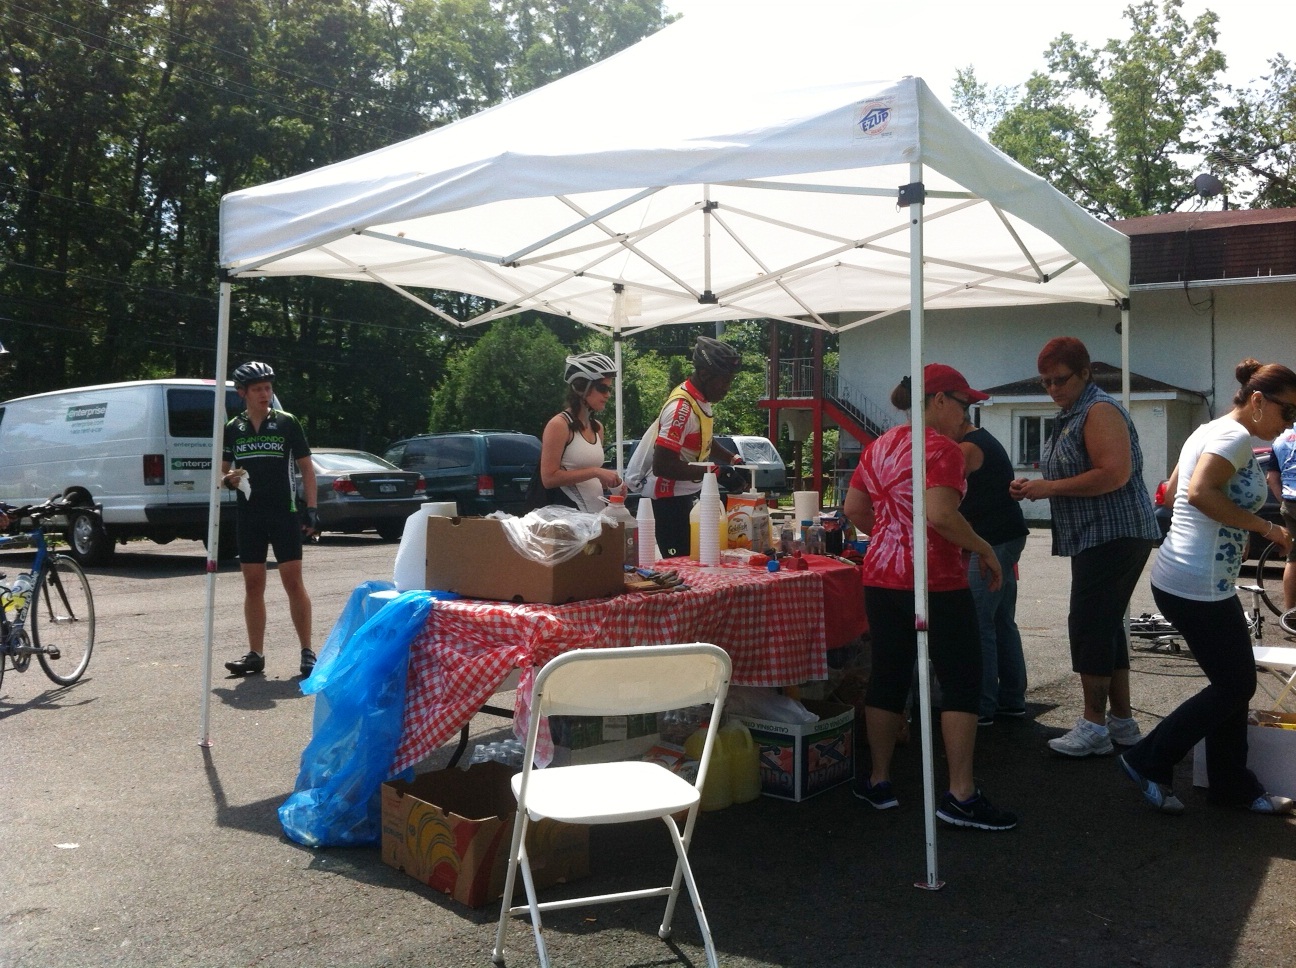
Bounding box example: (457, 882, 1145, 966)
(974, 0, 1225, 218)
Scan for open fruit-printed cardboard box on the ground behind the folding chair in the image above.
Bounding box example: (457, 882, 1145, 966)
(382, 763, 590, 907)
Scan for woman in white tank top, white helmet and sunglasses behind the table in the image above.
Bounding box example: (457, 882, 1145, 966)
(540, 352, 621, 514)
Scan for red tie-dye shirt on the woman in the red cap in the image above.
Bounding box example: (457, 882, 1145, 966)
(850, 425, 968, 591)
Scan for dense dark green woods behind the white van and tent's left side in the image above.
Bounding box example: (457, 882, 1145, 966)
(0, 0, 662, 446)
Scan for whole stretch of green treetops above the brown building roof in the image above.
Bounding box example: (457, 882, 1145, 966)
(953, 0, 1296, 218)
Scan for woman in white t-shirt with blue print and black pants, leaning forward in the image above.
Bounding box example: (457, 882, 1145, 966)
(1120, 359, 1296, 814)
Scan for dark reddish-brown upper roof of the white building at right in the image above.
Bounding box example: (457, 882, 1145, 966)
(1109, 209, 1296, 286)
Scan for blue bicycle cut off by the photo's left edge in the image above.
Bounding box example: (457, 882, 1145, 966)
(0, 500, 95, 686)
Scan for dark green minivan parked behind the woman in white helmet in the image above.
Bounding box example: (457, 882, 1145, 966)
(382, 430, 540, 514)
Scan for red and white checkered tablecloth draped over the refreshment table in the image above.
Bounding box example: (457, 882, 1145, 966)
(393, 559, 864, 772)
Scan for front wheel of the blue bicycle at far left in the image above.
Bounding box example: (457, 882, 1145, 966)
(27, 555, 95, 686)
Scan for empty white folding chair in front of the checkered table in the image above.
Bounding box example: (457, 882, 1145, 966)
(491, 643, 730, 968)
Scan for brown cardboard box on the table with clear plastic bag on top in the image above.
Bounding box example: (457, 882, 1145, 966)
(426, 517, 625, 605)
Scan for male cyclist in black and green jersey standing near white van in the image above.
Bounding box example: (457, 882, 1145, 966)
(220, 362, 319, 675)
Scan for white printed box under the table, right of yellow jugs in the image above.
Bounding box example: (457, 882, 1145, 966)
(737, 701, 855, 800)
